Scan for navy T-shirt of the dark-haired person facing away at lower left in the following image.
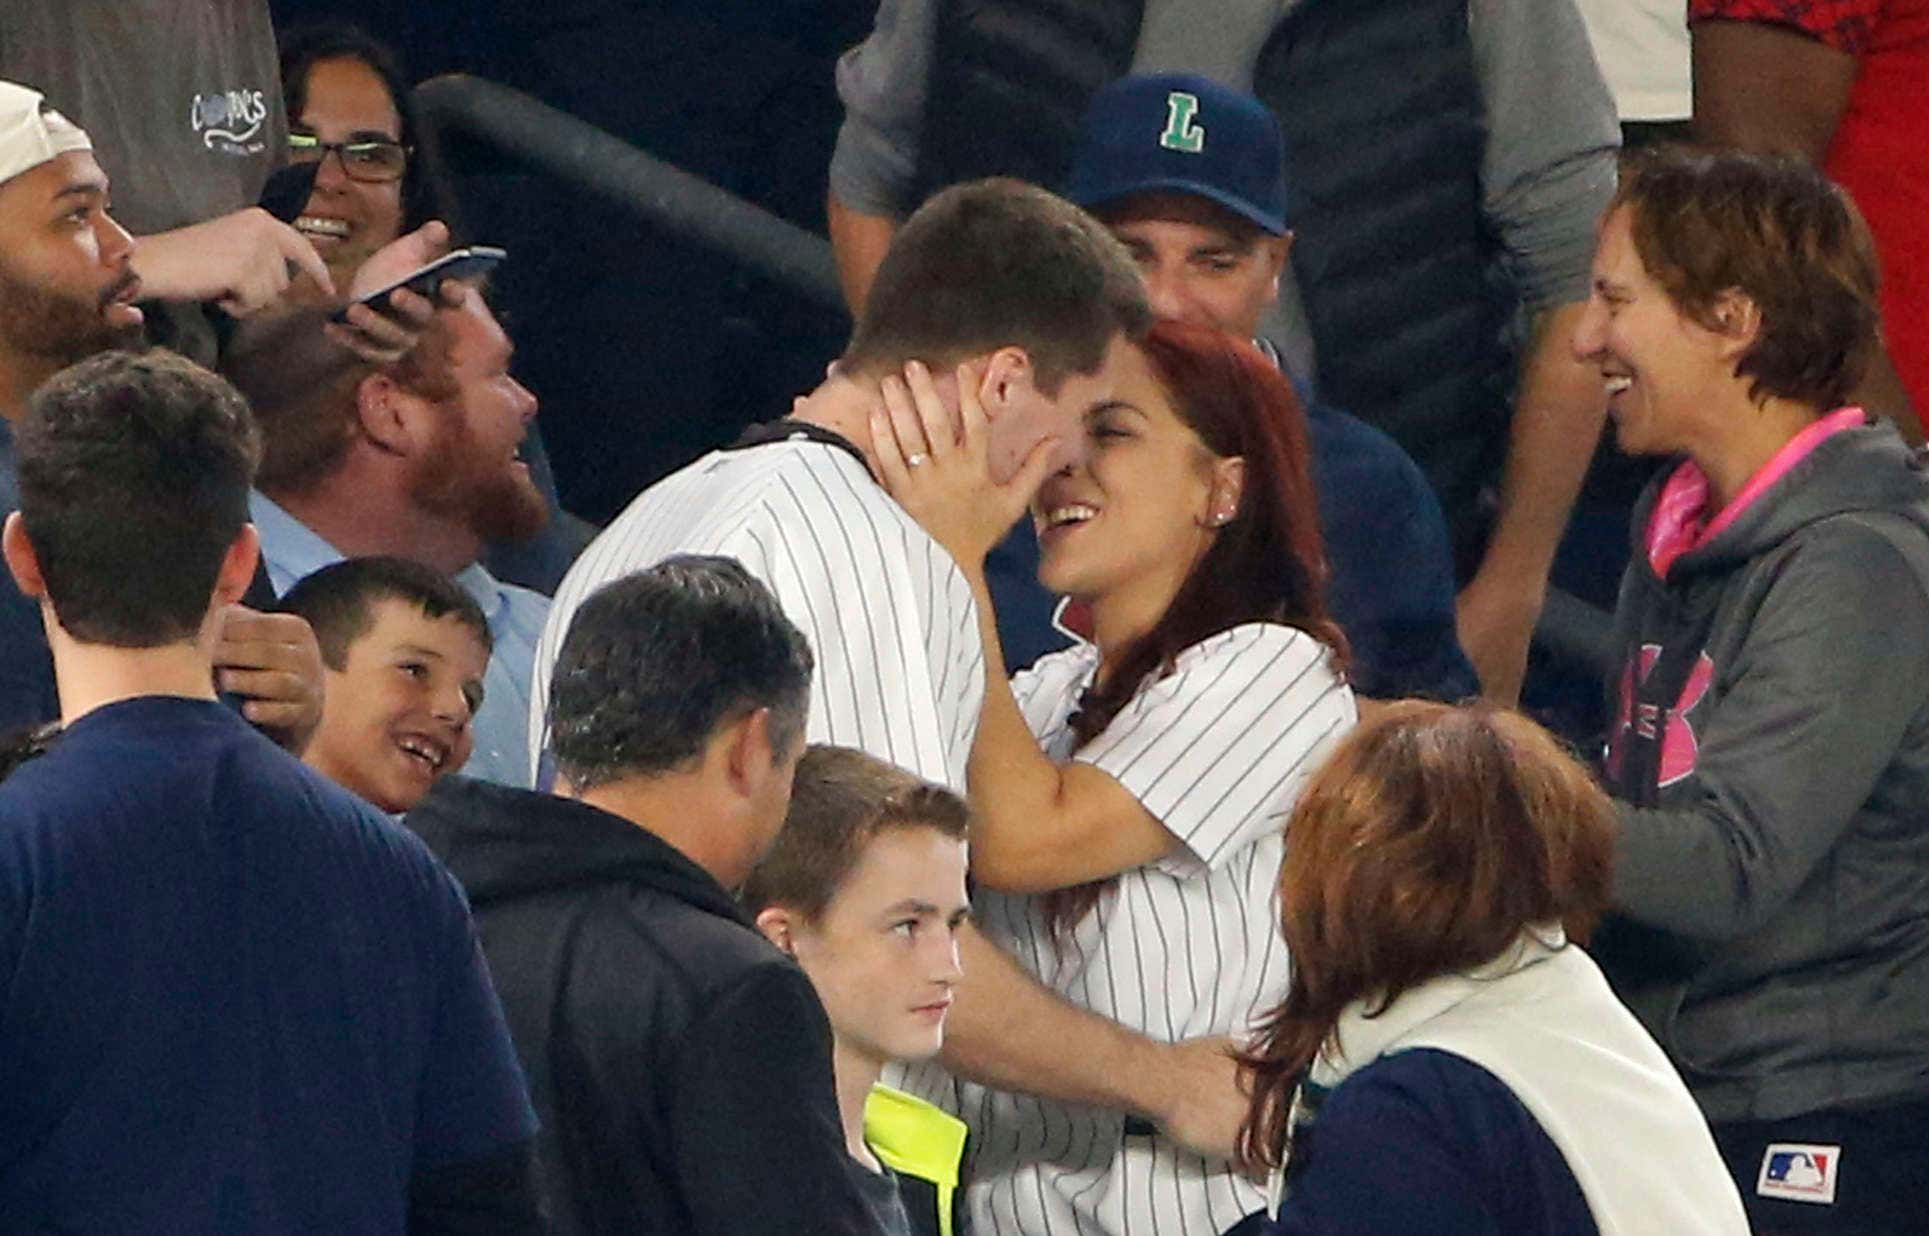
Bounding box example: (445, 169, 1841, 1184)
(0, 696, 534, 1234)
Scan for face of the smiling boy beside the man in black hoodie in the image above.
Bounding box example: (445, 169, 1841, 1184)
(303, 600, 488, 814)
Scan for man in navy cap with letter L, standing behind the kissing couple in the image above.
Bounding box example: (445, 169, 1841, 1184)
(997, 73, 1480, 700)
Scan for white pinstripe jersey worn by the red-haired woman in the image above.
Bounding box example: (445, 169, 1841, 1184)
(907, 623, 1354, 1236)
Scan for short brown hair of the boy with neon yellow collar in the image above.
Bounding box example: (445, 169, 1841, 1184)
(741, 744, 970, 922)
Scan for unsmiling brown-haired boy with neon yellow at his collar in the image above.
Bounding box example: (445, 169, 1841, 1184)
(743, 746, 970, 1236)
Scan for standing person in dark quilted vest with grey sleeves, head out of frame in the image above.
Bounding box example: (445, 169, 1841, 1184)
(828, 0, 1620, 700)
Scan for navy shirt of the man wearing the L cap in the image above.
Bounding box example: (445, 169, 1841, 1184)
(986, 384, 1480, 700)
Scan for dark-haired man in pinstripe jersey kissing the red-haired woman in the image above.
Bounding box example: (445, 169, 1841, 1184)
(530, 179, 1244, 1187)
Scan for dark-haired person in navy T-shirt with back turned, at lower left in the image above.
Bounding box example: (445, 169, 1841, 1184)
(0, 351, 540, 1236)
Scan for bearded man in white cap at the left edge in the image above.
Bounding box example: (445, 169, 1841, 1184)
(0, 81, 320, 746)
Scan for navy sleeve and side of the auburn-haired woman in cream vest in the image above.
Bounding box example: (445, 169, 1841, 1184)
(1233, 1049, 1599, 1236)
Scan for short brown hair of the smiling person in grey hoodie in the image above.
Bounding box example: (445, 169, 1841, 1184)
(1609, 147, 1881, 409)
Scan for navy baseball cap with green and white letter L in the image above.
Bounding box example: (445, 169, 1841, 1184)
(1065, 73, 1287, 235)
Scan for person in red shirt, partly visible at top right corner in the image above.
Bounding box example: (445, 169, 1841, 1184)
(1688, 0, 1929, 442)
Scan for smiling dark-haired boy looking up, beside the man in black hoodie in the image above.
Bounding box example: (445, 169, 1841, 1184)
(280, 557, 490, 816)
